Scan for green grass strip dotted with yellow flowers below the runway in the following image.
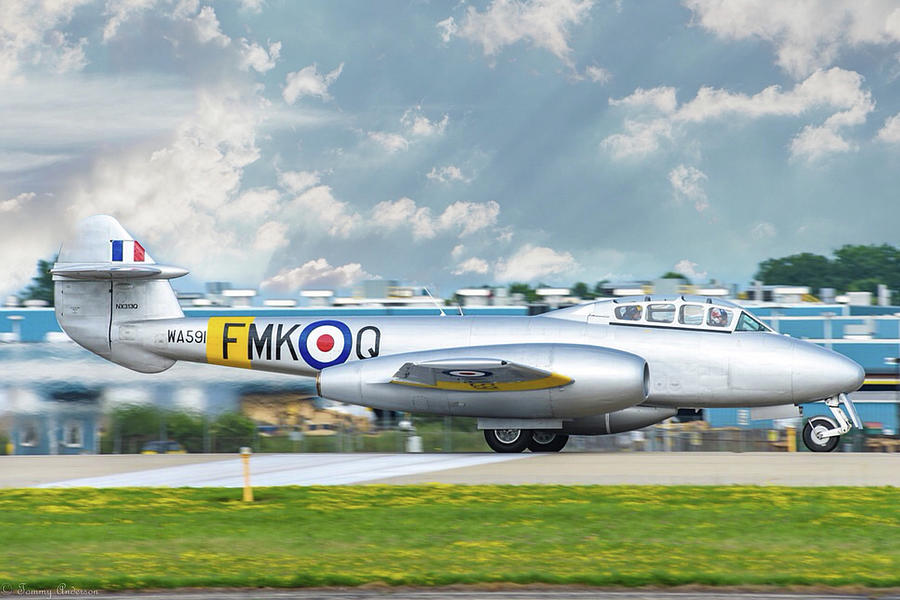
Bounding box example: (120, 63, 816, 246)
(0, 485, 900, 589)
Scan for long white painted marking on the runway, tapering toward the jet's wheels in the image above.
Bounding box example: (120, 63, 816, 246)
(37, 454, 534, 488)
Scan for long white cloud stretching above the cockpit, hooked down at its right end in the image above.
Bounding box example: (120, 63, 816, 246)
(602, 67, 875, 160)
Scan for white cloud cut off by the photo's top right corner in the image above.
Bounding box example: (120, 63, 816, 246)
(684, 0, 900, 78)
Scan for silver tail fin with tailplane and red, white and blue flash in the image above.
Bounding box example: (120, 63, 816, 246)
(51, 215, 187, 373)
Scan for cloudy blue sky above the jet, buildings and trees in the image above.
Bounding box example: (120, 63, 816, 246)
(0, 0, 900, 295)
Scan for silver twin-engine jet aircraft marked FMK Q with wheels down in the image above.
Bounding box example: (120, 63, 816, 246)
(52, 215, 864, 452)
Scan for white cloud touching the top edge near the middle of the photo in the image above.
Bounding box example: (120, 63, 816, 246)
(437, 0, 593, 67)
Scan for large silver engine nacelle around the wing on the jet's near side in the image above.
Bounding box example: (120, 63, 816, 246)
(317, 344, 650, 419)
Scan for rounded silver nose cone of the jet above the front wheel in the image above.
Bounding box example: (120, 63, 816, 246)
(791, 340, 865, 402)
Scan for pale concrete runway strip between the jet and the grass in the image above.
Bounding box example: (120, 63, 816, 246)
(0, 452, 900, 487)
